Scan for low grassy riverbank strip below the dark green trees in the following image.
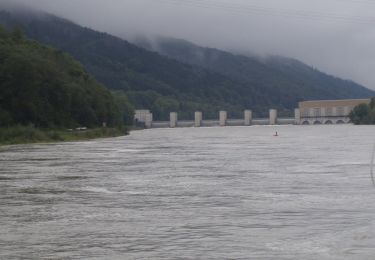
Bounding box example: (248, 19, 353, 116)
(0, 126, 128, 145)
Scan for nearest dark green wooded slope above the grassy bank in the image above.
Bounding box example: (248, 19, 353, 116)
(0, 26, 133, 128)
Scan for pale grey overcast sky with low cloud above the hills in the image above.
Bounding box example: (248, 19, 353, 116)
(0, 0, 375, 89)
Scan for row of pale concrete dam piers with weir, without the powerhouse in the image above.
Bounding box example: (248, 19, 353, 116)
(135, 109, 300, 128)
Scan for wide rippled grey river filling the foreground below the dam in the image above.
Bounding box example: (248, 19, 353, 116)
(0, 125, 375, 260)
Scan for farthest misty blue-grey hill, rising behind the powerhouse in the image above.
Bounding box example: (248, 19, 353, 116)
(135, 37, 374, 102)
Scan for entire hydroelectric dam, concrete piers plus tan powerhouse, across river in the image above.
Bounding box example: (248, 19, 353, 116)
(135, 99, 370, 128)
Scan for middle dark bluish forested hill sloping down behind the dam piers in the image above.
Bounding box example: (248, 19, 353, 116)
(0, 8, 278, 119)
